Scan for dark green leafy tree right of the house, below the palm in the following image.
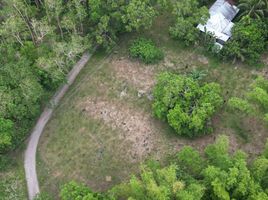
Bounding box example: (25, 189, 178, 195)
(221, 17, 268, 65)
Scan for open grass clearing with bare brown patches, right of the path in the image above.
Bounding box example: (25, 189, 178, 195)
(37, 13, 268, 195)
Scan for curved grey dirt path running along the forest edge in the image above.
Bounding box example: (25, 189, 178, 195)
(24, 52, 92, 200)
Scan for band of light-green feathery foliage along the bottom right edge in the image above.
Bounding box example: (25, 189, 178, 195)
(60, 136, 268, 200)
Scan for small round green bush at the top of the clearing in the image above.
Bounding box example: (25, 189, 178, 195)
(129, 38, 164, 64)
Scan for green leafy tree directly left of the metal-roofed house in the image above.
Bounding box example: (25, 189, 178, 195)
(170, 0, 209, 45)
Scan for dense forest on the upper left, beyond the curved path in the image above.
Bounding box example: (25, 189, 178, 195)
(0, 0, 165, 153)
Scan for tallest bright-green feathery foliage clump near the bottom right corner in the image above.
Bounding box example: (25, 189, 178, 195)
(202, 137, 268, 199)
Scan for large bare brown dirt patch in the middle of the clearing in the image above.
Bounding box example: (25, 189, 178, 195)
(81, 99, 157, 160)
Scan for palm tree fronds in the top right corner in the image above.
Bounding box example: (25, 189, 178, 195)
(238, 0, 268, 19)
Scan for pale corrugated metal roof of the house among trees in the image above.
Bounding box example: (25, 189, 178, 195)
(197, 0, 239, 42)
